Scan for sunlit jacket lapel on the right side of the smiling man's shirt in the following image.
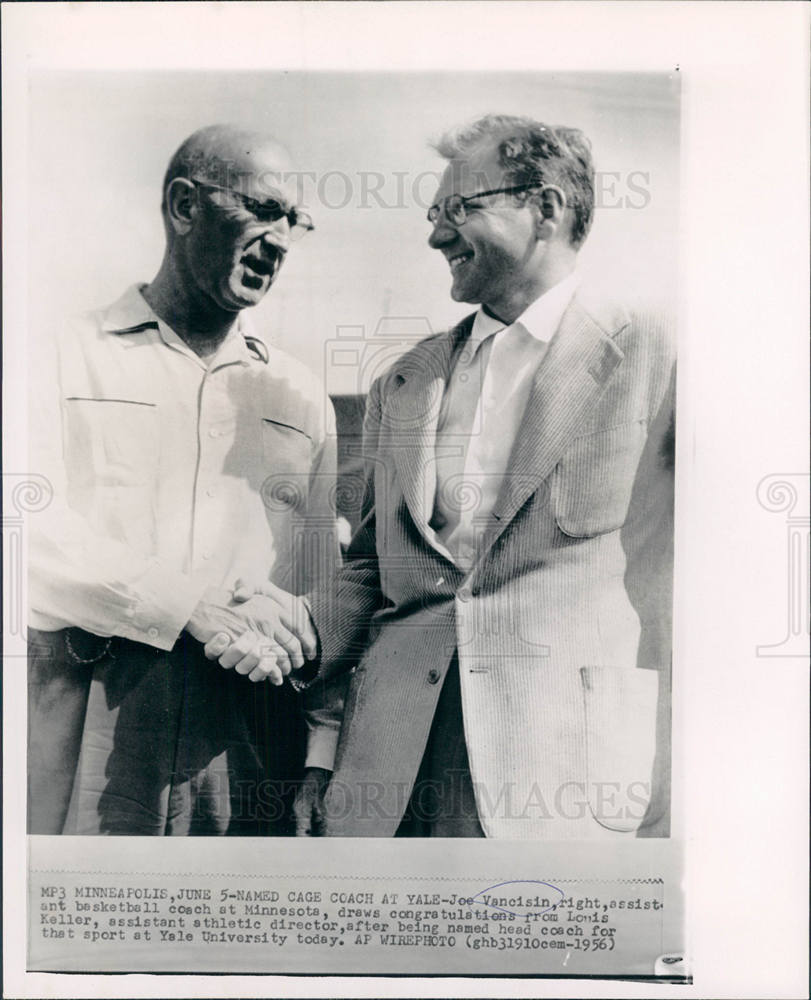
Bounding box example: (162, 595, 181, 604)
(482, 296, 628, 553)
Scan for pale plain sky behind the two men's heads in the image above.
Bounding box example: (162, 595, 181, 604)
(29, 70, 680, 392)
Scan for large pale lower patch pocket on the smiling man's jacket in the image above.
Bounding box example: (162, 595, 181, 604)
(580, 667, 659, 833)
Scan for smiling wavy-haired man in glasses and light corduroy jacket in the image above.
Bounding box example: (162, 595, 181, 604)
(297, 116, 673, 839)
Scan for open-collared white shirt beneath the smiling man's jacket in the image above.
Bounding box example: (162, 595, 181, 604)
(431, 274, 577, 570)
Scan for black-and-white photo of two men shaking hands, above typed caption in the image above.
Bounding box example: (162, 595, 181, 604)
(28, 73, 679, 840)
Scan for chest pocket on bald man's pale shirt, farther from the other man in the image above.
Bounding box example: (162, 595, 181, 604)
(65, 396, 160, 487)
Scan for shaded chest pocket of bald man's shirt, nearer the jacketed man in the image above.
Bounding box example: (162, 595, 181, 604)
(260, 417, 313, 513)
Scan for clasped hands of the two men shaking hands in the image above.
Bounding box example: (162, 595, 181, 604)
(186, 580, 318, 685)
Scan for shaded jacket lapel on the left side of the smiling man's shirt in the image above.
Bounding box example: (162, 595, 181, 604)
(384, 316, 473, 555)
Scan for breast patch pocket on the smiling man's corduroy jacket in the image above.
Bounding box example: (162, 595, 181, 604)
(551, 420, 647, 538)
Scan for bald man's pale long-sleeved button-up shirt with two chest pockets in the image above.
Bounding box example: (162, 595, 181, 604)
(28, 286, 337, 649)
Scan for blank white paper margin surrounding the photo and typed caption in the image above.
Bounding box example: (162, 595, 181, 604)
(3, 2, 809, 998)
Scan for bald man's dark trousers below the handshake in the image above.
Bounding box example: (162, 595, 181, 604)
(28, 629, 306, 836)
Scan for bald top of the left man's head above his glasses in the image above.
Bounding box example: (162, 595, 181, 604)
(162, 125, 293, 222)
